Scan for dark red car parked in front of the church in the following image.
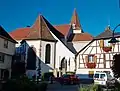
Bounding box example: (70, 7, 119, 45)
(59, 74, 80, 84)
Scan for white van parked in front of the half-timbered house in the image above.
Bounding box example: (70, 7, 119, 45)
(94, 72, 118, 87)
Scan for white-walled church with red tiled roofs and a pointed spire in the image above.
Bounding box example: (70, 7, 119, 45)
(9, 9, 93, 77)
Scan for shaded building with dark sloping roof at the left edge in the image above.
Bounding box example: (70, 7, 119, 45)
(0, 26, 17, 79)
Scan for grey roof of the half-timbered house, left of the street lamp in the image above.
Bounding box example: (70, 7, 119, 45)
(94, 26, 112, 39)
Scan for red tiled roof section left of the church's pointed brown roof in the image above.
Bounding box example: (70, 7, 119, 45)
(9, 27, 31, 40)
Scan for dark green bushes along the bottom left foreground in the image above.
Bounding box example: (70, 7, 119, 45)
(3, 77, 47, 91)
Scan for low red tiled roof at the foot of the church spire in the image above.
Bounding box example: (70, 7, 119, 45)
(68, 33, 93, 42)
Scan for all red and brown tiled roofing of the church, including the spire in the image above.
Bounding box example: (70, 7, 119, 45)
(10, 9, 93, 41)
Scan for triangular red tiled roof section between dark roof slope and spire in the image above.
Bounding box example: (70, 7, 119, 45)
(54, 24, 71, 36)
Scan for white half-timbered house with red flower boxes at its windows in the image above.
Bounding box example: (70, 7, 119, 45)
(76, 26, 120, 74)
